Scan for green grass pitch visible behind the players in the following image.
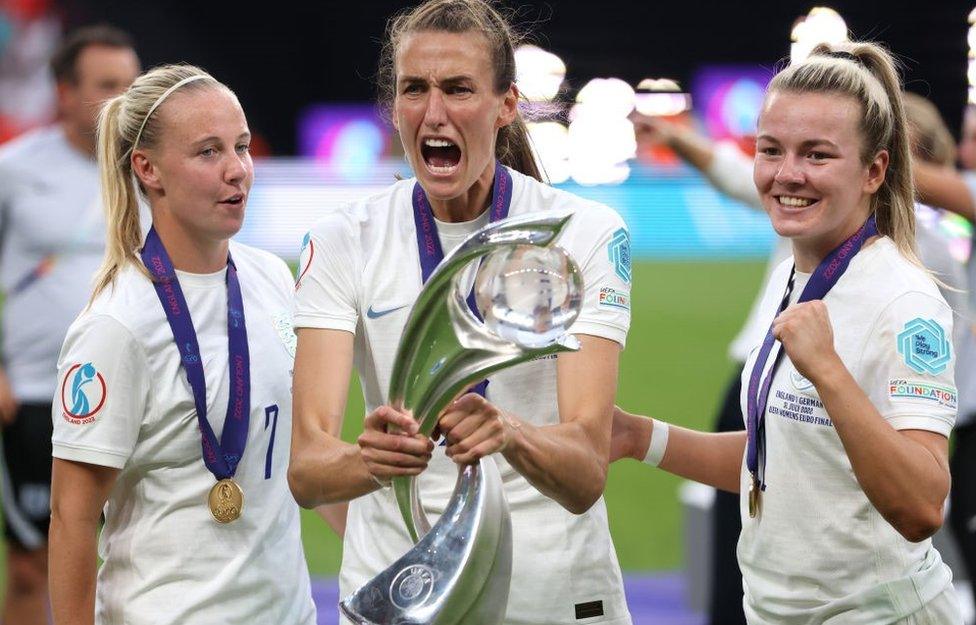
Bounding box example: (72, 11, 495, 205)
(302, 262, 763, 576)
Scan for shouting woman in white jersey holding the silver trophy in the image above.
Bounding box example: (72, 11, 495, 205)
(289, 0, 631, 625)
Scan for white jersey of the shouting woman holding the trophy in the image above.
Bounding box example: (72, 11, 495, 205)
(295, 171, 630, 625)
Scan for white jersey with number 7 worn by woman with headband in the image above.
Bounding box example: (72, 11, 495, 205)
(53, 242, 315, 625)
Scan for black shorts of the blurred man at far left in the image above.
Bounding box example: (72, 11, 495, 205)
(0, 404, 53, 551)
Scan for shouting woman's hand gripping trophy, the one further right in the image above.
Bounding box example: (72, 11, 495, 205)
(437, 393, 513, 464)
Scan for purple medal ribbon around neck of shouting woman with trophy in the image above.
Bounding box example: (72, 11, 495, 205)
(413, 161, 512, 397)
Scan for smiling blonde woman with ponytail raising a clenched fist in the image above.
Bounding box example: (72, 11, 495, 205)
(612, 43, 962, 625)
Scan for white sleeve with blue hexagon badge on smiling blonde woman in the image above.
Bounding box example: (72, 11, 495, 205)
(860, 291, 958, 436)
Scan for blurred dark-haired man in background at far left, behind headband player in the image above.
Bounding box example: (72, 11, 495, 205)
(0, 26, 139, 624)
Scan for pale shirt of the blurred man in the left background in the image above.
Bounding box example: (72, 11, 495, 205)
(0, 126, 105, 403)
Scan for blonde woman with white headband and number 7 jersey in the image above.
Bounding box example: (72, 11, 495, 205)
(50, 65, 315, 625)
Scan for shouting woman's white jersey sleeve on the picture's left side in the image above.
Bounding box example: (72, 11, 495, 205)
(295, 211, 362, 334)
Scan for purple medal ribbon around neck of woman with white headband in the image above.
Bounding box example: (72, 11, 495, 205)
(141, 228, 251, 480)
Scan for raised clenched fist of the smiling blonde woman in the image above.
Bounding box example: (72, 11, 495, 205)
(773, 300, 840, 384)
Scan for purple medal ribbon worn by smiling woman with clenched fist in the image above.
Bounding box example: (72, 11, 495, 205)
(746, 214, 878, 490)
